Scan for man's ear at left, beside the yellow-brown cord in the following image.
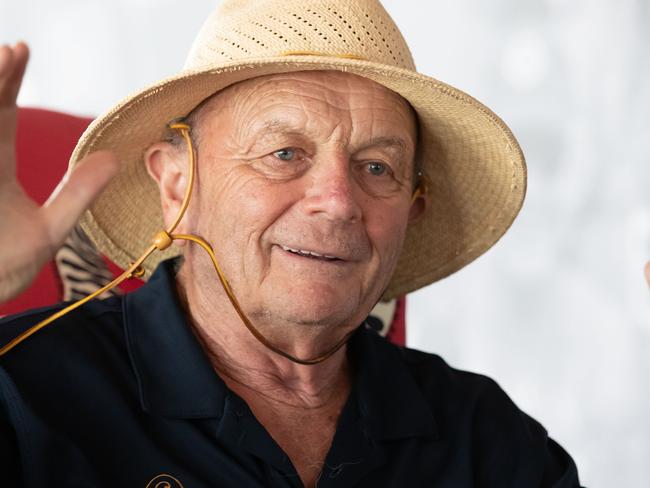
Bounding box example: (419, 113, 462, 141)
(144, 142, 189, 240)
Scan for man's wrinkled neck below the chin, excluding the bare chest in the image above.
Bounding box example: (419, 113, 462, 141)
(176, 266, 350, 409)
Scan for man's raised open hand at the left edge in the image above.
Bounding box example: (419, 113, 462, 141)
(0, 43, 119, 303)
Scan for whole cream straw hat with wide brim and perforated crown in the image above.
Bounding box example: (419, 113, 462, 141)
(70, 0, 526, 298)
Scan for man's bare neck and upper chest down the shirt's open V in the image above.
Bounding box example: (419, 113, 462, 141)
(176, 265, 354, 487)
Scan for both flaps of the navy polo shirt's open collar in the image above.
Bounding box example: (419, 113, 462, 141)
(123, 261, 437, 440)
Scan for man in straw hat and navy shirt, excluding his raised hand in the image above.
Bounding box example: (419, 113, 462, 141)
(0, 0, 578, 487)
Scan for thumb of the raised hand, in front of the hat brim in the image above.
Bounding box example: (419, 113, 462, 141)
(41, 151, 119, 248)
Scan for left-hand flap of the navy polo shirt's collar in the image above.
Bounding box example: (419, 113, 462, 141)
(123, 260, 227, 418)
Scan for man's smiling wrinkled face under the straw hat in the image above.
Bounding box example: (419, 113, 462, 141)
(181, 72, 416, 332)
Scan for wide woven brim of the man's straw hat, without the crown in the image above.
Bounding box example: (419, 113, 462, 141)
(70, 56, 526, 299)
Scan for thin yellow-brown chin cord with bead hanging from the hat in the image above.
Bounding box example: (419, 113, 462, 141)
(0, 122, 356, 365)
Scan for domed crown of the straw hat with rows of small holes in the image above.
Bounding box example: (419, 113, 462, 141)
(185, 0, 415, 70)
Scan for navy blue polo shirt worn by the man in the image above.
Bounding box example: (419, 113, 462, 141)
(0, 262, 579, 488)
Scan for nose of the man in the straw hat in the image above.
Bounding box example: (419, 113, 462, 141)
(304, 155, 363, 222)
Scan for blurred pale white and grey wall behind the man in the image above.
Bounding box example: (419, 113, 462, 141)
(0, 0, 650, 487)
